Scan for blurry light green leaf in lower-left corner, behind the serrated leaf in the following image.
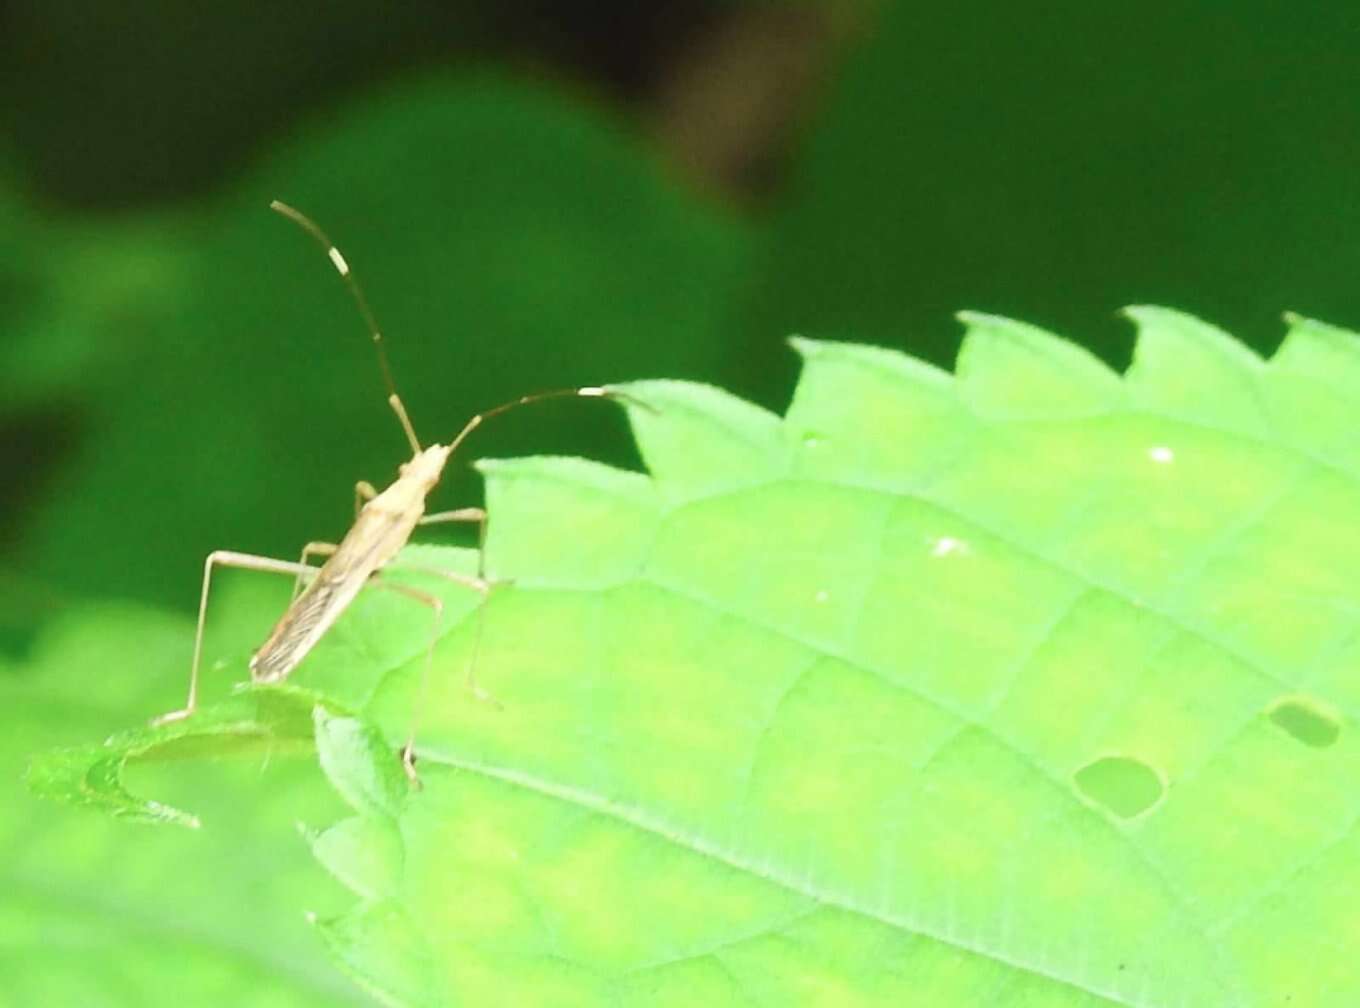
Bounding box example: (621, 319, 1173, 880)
(9, 593, 373, 1008)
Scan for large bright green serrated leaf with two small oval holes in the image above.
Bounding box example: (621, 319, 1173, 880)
(29, 309, 1360, 1008)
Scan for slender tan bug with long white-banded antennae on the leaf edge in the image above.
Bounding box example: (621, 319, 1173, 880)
(152, 200, 646, 782)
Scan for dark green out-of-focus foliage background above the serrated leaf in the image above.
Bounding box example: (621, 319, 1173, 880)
(0, 0, 1360, 1003)
